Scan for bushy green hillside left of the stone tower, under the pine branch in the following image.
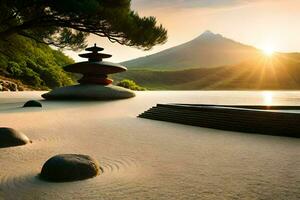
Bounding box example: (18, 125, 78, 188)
(0, 36, 74, 89)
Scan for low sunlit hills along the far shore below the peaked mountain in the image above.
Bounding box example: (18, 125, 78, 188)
(114, 53, 300, 90)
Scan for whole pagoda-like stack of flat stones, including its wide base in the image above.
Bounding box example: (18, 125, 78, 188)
(42, 44, 135, 100)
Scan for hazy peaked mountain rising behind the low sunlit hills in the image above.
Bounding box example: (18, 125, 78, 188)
(122, 31, 260, 70)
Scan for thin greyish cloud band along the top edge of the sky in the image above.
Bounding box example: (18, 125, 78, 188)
(133, 0, 261, 8)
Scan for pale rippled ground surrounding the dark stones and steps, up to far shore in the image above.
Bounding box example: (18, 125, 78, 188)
(0, 91, 300, 200)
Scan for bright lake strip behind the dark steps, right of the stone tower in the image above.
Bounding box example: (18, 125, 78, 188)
(130, 90, 300, 106)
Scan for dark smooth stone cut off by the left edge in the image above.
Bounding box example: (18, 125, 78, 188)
(0, 127, 31, 148)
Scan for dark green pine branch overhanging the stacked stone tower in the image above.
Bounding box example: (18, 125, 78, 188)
(0, 0, 167, 49)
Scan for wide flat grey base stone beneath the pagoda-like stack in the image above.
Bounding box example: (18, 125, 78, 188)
(42, 84, 135, 100)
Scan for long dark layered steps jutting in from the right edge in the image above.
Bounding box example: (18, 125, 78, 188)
(138, 104, 300, 138)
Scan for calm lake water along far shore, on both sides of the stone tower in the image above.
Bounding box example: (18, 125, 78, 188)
(0, 90, 300, 106)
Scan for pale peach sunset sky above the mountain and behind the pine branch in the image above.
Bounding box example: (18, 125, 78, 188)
(65, 0, 300, 62)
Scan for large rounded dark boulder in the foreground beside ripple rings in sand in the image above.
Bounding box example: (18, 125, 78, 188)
(40, 154, 103, 182)
